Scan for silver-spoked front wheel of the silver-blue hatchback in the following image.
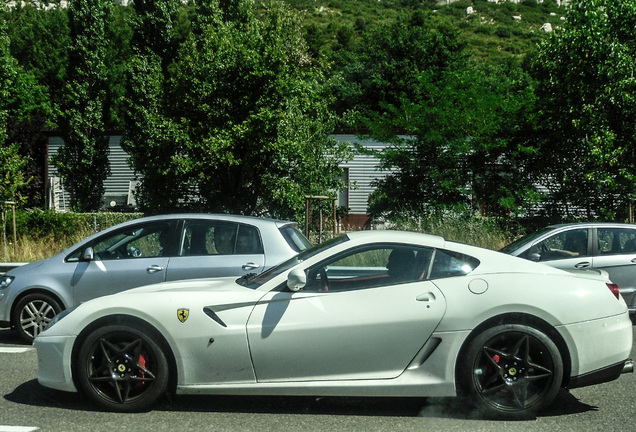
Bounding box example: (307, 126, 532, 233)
(11, 293, 62, 342)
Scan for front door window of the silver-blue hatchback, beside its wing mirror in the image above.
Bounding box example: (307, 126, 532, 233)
(93, 223, 170, 260)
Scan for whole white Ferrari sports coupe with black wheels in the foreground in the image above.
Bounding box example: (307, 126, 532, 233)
(34, 231, 633, 418)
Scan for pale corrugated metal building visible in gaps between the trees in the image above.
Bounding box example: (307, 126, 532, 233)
(48, 134, 387, 221)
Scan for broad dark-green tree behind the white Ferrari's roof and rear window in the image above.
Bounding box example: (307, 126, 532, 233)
(370, 62, 536, 218)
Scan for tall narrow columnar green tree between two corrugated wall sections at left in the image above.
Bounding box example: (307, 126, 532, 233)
(53, 0, 110, 211)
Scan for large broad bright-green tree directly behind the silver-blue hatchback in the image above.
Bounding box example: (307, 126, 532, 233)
(127, 1, 347, 218)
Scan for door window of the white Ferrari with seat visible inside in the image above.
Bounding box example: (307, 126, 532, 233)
(305, 245, 432, 291)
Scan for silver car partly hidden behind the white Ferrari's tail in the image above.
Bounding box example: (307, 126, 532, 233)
(501, 222, 636, 315)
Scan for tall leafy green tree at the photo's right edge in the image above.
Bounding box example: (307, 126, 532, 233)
(533, 0, 636, 219)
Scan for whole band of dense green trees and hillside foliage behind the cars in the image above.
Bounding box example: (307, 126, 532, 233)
(0, 0, 636, 228)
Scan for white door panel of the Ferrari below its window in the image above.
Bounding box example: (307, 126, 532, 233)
(248, 281, 445, 382)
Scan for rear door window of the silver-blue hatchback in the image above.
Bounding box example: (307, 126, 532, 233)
(180, 220, 238, 255)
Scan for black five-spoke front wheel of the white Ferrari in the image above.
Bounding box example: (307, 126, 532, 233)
(75, 325, 169, 412)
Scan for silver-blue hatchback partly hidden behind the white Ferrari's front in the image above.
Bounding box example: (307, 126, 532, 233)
(0, 214, 311, 341)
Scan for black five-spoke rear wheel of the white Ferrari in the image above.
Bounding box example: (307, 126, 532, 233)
(457, 324, 563, 419)
